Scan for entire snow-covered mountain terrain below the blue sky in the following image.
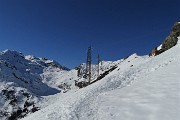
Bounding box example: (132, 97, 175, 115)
(0, 22, 180, 120)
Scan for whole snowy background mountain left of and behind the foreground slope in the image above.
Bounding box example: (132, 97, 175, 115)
(0, 50, 118, 120)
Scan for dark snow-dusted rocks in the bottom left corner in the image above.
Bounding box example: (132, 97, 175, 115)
(0, 88, 39, 120)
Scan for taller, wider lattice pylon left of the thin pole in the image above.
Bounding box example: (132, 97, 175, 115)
(86, 46, 91, 84)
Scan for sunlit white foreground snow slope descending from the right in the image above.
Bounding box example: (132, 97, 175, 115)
(22, 37, 180, 120)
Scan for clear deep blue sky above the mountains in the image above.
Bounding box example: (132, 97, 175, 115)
(0, 0, 180, 68)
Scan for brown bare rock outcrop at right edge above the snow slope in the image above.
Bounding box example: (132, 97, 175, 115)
(149, 22, 180, 56)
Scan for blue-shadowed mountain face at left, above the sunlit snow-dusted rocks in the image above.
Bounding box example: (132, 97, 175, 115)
(0, 50, 67, 95)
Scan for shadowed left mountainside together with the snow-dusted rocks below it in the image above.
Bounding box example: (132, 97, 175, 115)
(0, 50, 67, 119)
